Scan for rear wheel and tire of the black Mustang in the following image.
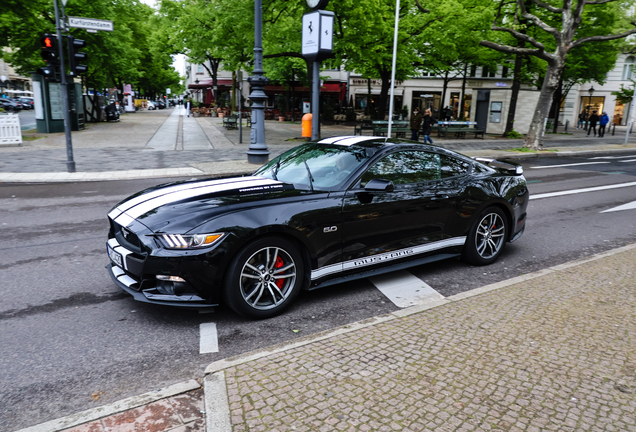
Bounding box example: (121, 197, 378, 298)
(462, 207, 508, 266)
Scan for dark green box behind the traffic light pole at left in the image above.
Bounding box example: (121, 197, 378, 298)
(31, 74, 85, 133)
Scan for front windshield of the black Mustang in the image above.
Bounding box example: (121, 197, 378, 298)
(254, 143, 375, 191)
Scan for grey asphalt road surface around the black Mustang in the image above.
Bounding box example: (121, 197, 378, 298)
(0, 152, 636, 431)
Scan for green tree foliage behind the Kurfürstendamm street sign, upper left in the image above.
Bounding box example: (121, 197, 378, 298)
(0, 0, 180, 93)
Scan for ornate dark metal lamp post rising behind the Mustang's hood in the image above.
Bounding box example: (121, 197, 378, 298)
(246, 0, 269, 164)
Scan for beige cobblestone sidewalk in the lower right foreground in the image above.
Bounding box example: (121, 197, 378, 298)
(215, 247, 636, 432)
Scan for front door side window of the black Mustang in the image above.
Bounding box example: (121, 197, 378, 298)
(360, 150, 442, 187)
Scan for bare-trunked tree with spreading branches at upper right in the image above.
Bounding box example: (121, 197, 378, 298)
(480, 0, 636, 149)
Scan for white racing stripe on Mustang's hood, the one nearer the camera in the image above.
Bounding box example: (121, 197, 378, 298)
(115, 177, 283, 226)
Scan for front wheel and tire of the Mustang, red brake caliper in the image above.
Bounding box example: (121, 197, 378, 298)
(223, 237, 304, 319)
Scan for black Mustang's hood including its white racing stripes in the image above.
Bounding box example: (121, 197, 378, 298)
(108, 176, 294, 233)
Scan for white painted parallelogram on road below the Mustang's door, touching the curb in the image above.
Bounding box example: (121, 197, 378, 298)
(369, 270, 444, 308)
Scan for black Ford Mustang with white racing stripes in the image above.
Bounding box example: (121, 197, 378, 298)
(107, 137, 528, 318)
